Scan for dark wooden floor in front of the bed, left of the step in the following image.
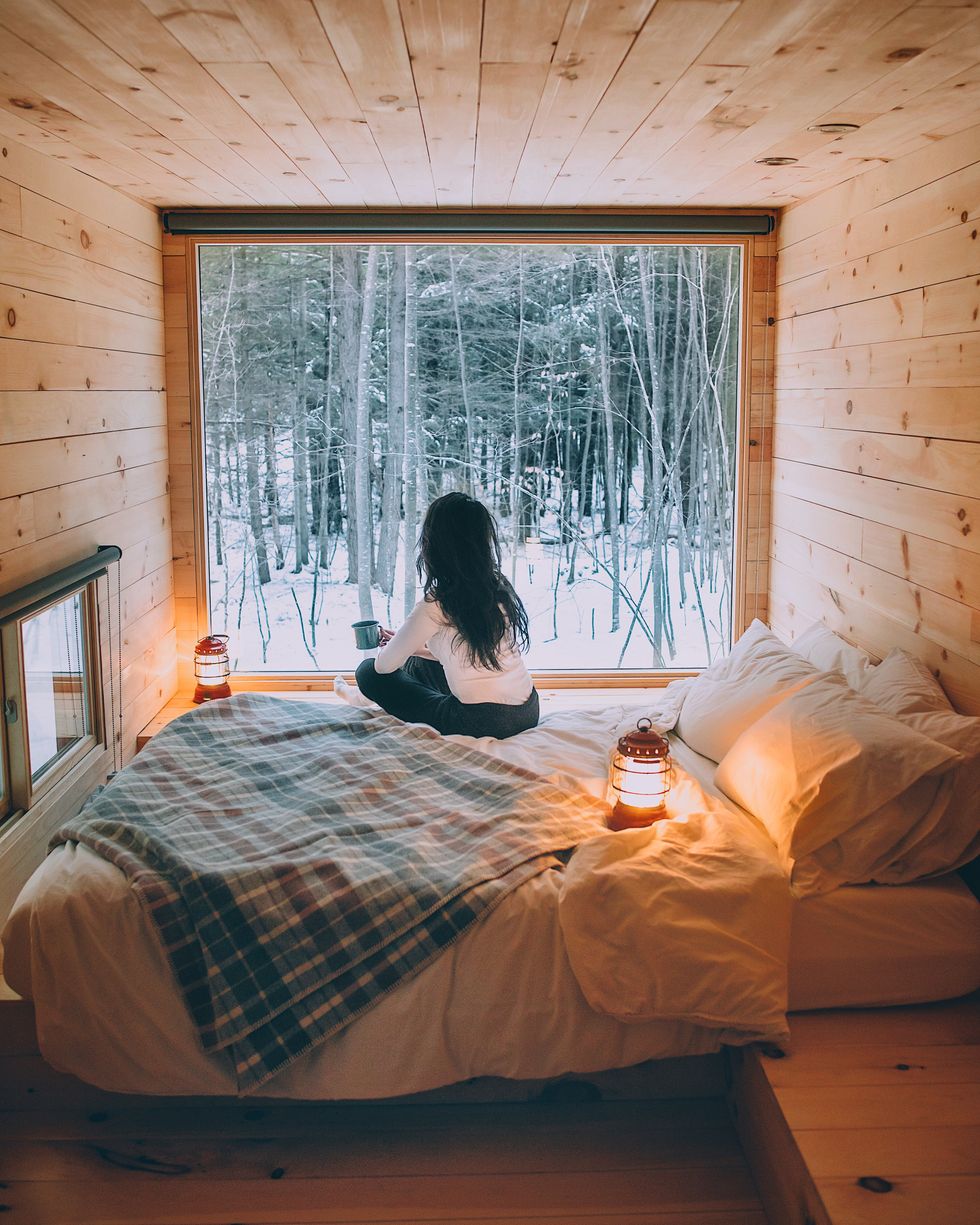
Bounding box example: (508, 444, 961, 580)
(0, 1082, 766, 1225)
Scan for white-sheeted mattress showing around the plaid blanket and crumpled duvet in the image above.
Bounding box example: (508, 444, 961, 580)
(2, 698, 980, 1100)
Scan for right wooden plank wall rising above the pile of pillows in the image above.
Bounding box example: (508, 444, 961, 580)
(769, 127, 980, 714)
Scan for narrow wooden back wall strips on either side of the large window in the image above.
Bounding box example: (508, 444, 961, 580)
(163, 234, 775, 693)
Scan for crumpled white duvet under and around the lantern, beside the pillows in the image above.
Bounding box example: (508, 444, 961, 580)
(451, 681, 791, 1044)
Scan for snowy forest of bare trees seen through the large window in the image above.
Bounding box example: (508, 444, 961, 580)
(200, 243, 740, 671)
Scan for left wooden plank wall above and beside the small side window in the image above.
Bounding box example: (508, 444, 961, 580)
(0, 140, 176, 911)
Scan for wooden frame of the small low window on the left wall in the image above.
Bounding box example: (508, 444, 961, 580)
(0, 577, 107, 823)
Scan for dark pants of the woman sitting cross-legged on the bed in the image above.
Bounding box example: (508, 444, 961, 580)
(356, 655, 538, 740)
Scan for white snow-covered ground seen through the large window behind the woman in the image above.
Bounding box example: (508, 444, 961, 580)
(211, 519, 729, 673)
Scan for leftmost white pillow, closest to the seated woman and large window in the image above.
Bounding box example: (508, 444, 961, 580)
(676, 621, 817, 762)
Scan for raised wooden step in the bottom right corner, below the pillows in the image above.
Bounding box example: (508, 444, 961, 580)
(729, 996, 980, 1225)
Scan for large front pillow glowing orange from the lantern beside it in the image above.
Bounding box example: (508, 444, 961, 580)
(714, 673, 962, 895)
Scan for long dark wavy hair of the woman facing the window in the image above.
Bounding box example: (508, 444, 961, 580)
(415, 494, 530, 671)
